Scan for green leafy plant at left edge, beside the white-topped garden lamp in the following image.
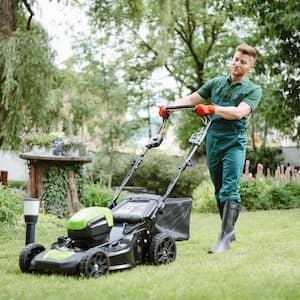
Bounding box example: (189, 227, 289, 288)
(0, 184, 23, 225)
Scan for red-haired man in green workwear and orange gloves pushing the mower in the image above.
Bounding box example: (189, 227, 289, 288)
(159, 44, 262, 253)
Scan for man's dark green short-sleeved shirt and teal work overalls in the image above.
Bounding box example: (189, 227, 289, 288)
(198, 76, 261, 203)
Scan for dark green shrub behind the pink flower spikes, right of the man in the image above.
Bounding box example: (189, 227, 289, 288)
(246, 147, 283, 175)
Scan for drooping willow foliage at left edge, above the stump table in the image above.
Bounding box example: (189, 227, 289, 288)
(0, 27, 55, 149)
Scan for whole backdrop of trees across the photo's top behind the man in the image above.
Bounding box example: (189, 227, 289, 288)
(0, 0, 300, 162)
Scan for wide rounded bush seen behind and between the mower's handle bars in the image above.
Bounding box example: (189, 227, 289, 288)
(90, 150, 206, 197)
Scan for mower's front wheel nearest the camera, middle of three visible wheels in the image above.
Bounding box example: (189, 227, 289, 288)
(79, 249, 110, 278)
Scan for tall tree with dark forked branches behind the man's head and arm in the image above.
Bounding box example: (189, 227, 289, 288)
(89, 0, 253, 145)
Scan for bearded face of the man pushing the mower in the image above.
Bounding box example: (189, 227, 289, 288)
(231, 51, 254, 77)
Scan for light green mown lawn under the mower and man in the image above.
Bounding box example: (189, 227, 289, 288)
(0, 209, 300, 300)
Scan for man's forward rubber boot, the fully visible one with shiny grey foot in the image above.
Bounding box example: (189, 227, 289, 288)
(208, 201, 240, 253)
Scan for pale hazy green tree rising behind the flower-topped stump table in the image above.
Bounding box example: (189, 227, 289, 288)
(63, 34, 141, 188)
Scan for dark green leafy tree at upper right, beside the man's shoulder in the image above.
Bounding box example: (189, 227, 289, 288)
(240, 0, 300, 141)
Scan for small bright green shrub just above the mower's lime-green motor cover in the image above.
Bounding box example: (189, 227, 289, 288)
(81, 183, 113, 207)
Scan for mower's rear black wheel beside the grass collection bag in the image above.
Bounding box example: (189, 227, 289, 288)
(149, 233, 176, 265)
